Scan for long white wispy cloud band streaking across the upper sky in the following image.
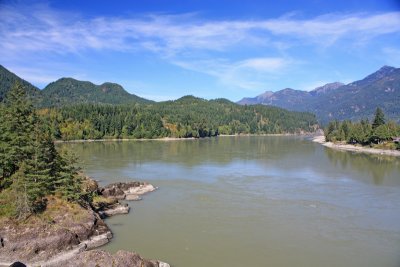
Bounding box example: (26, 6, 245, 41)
(0, 6, 400, 56)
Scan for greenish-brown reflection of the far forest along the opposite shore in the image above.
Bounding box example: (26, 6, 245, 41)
(59, 136, 315, 167)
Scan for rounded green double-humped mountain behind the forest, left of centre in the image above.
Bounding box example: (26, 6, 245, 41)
(41, 78, 152, 107)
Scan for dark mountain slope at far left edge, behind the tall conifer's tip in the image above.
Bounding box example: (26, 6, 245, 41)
(0, 65, 40, 102)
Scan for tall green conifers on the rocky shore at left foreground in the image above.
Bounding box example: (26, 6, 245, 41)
(0, 83, 84, 220)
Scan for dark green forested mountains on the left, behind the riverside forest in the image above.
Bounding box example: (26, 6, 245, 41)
(0, 65, 153, 107)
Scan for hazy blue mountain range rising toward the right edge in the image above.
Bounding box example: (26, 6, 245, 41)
(237, 66, 400, 124)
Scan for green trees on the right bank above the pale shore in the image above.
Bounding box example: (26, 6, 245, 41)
(324, 108, 400, 149)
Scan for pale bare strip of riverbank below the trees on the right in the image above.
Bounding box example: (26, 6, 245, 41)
(312, 135, 400, 157)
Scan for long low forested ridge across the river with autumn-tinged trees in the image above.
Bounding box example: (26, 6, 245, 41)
(38, 96, 317, 140)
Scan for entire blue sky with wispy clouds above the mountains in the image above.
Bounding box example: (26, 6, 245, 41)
(0, 0, 400, 101)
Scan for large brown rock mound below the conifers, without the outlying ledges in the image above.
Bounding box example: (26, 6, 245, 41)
(0, 197, 112, 264)
